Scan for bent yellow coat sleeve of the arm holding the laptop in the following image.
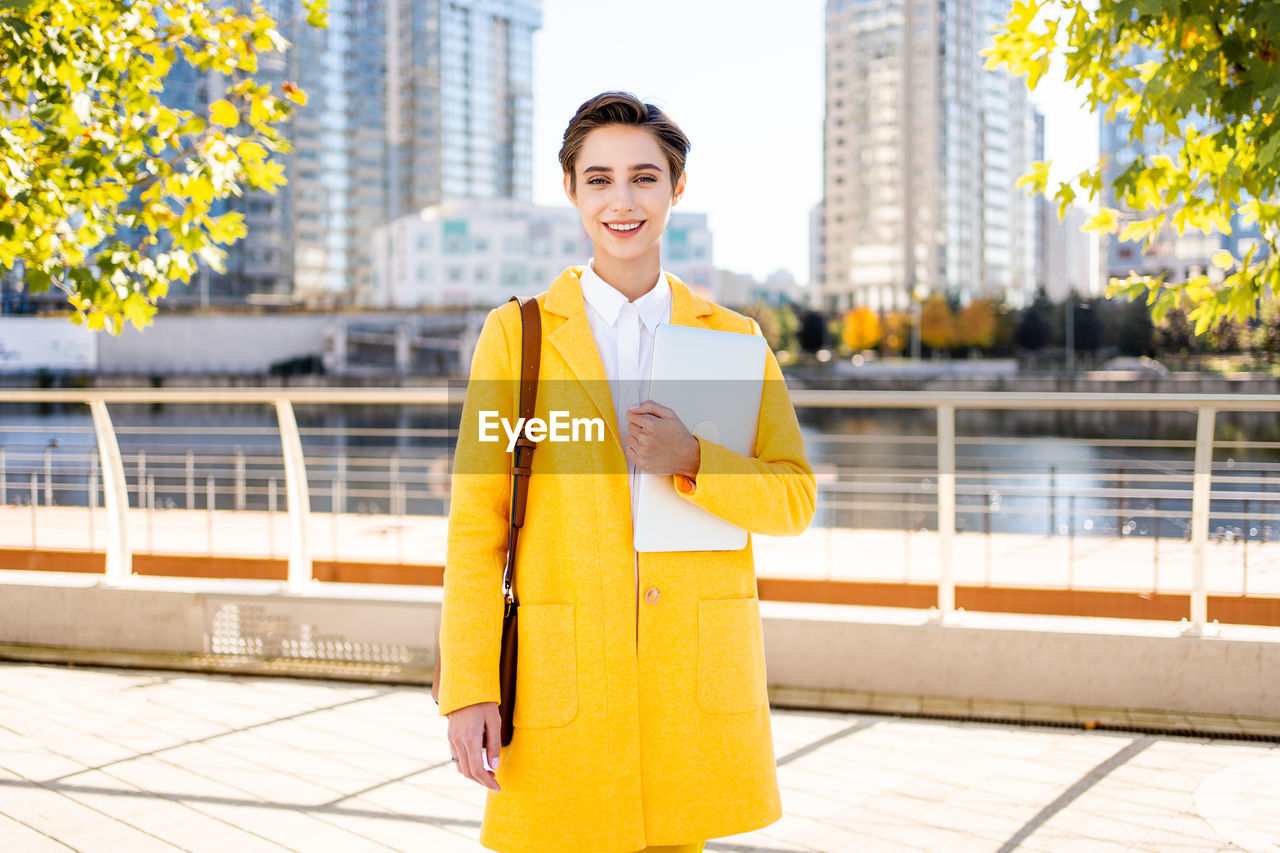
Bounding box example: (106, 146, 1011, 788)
(673, 320, 818, 535)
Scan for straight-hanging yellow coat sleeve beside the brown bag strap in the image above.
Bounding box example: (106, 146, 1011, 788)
(439, 304, 520, 716)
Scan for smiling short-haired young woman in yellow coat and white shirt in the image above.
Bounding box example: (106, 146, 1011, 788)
(439, 92, 815, 853)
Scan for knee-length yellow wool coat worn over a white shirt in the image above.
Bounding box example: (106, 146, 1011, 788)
(439, 268, 815, 853)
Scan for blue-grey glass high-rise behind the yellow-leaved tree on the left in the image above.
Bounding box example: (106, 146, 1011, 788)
(166, 0, 541, 306)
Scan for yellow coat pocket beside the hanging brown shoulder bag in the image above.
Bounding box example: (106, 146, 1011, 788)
(512, 605, 577, 729)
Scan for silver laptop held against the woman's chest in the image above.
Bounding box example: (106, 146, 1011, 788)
(634, 324, 768, 551)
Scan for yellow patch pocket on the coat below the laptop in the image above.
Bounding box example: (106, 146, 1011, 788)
(698, 598, 768, 713)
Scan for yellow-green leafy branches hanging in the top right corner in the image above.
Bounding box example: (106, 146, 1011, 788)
(982, 0, 1280, 334)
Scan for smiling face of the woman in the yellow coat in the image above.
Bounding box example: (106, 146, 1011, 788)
(564, 124, 685, 275)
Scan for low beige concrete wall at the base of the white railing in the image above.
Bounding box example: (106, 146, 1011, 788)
(0, 573, 1280, 719)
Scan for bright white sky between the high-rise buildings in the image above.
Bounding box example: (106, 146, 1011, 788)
(534, 0, 1098, 282)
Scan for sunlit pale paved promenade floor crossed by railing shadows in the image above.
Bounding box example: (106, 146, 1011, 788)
(0, 663, 1280, 853)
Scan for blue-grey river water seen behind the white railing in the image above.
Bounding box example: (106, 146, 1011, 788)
(0, 403, 1280, 542)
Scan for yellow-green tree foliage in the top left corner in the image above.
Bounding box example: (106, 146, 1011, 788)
(0, 0, 326, 334)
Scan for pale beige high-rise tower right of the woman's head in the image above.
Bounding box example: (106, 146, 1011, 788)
(818, 0, 1037, 310)
